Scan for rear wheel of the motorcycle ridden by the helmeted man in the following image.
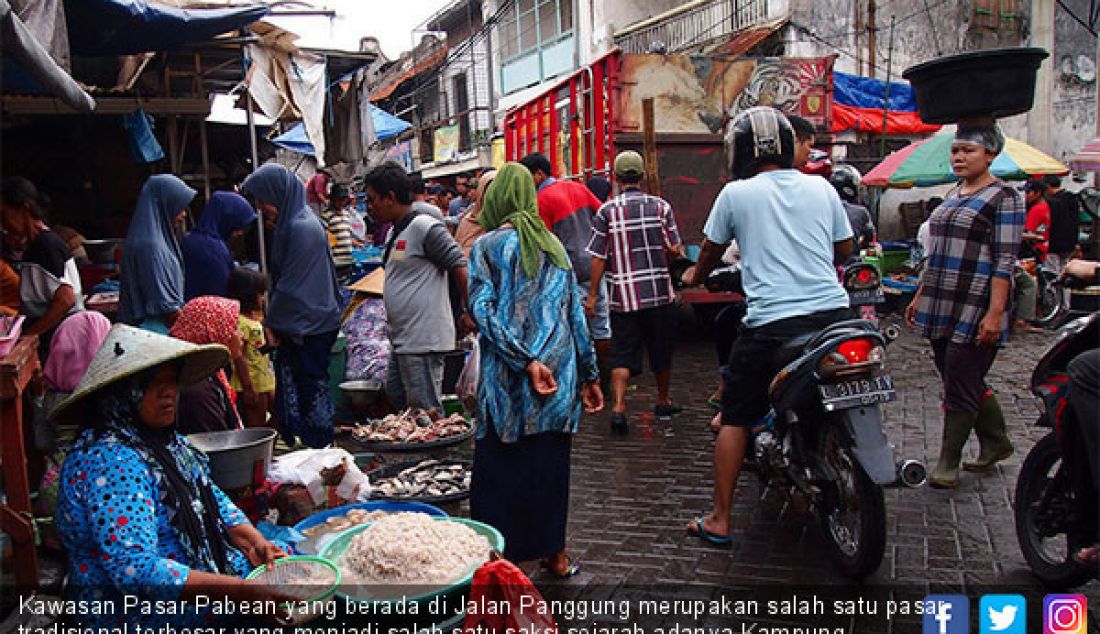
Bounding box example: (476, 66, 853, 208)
(817, 429, 887, 579)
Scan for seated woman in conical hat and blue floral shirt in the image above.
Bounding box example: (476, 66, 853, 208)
(53, 325, 286, 627)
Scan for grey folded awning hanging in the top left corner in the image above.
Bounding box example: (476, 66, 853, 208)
(0, 0, 96, 112)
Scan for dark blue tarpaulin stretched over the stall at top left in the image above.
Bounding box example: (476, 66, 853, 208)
(65, 0, 270, 56)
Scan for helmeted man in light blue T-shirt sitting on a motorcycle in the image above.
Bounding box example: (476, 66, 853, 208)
(683, 107, 853, 545)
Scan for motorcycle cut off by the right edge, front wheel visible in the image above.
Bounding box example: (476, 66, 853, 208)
(1015, 313, 1100, 588)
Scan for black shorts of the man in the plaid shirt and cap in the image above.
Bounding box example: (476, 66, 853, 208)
(612, 304, 677, 376)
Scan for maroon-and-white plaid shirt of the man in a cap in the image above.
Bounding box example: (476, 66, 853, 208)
(587, 189, 680, 313)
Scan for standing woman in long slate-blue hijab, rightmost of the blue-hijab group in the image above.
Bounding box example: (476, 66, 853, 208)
(241, 165, 342, 448)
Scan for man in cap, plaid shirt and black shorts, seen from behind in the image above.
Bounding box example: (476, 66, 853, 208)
(584, 151, 683, 433)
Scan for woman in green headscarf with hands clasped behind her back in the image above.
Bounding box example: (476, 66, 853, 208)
(470, 163, 604, 577)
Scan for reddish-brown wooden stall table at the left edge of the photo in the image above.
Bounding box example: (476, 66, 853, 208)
(0, 335, 40, 591)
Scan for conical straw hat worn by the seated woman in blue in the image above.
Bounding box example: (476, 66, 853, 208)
(51, 324, 229, 423)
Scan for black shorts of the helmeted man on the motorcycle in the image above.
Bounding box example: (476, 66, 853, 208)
(721, 308, 851, 427)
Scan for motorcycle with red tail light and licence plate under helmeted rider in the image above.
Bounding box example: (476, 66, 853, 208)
(705, 264, 926, 579)
